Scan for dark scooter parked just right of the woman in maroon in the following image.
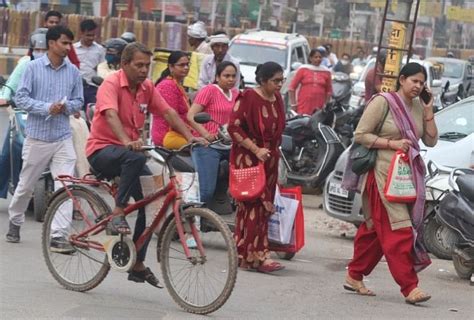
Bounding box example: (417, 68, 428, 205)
(281, 111, 344, 188)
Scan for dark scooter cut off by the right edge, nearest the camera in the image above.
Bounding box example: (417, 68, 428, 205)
(436, 168, 474, 285)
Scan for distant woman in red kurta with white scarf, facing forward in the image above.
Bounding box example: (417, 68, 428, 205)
(288, 49, 332, 114)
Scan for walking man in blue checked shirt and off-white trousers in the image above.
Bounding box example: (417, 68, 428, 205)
(6, 26, 84, 253)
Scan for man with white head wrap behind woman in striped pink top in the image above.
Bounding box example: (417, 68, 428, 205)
(198, 33, 240, 89)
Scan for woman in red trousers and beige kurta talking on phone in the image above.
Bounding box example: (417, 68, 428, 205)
(344, 63, 438, 304)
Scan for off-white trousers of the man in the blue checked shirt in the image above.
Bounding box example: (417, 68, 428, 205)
(8, 138, 76, 235)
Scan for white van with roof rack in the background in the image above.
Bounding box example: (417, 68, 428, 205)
(229, 30, 310, 87)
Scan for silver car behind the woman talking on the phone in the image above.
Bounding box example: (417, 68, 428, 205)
(323, 96, 474, 225)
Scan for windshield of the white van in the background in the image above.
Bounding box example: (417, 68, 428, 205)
(229, 42, 287, 69)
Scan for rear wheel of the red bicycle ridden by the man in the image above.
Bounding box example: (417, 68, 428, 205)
(42, 186, 111, 292)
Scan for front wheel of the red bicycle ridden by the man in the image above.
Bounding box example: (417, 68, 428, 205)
(158, 208, 237, 314)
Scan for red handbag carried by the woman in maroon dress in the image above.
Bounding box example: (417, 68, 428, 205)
(229, 112, 267, 201)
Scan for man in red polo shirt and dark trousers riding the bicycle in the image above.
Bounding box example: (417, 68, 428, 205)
(86, 42, 204, 288)
